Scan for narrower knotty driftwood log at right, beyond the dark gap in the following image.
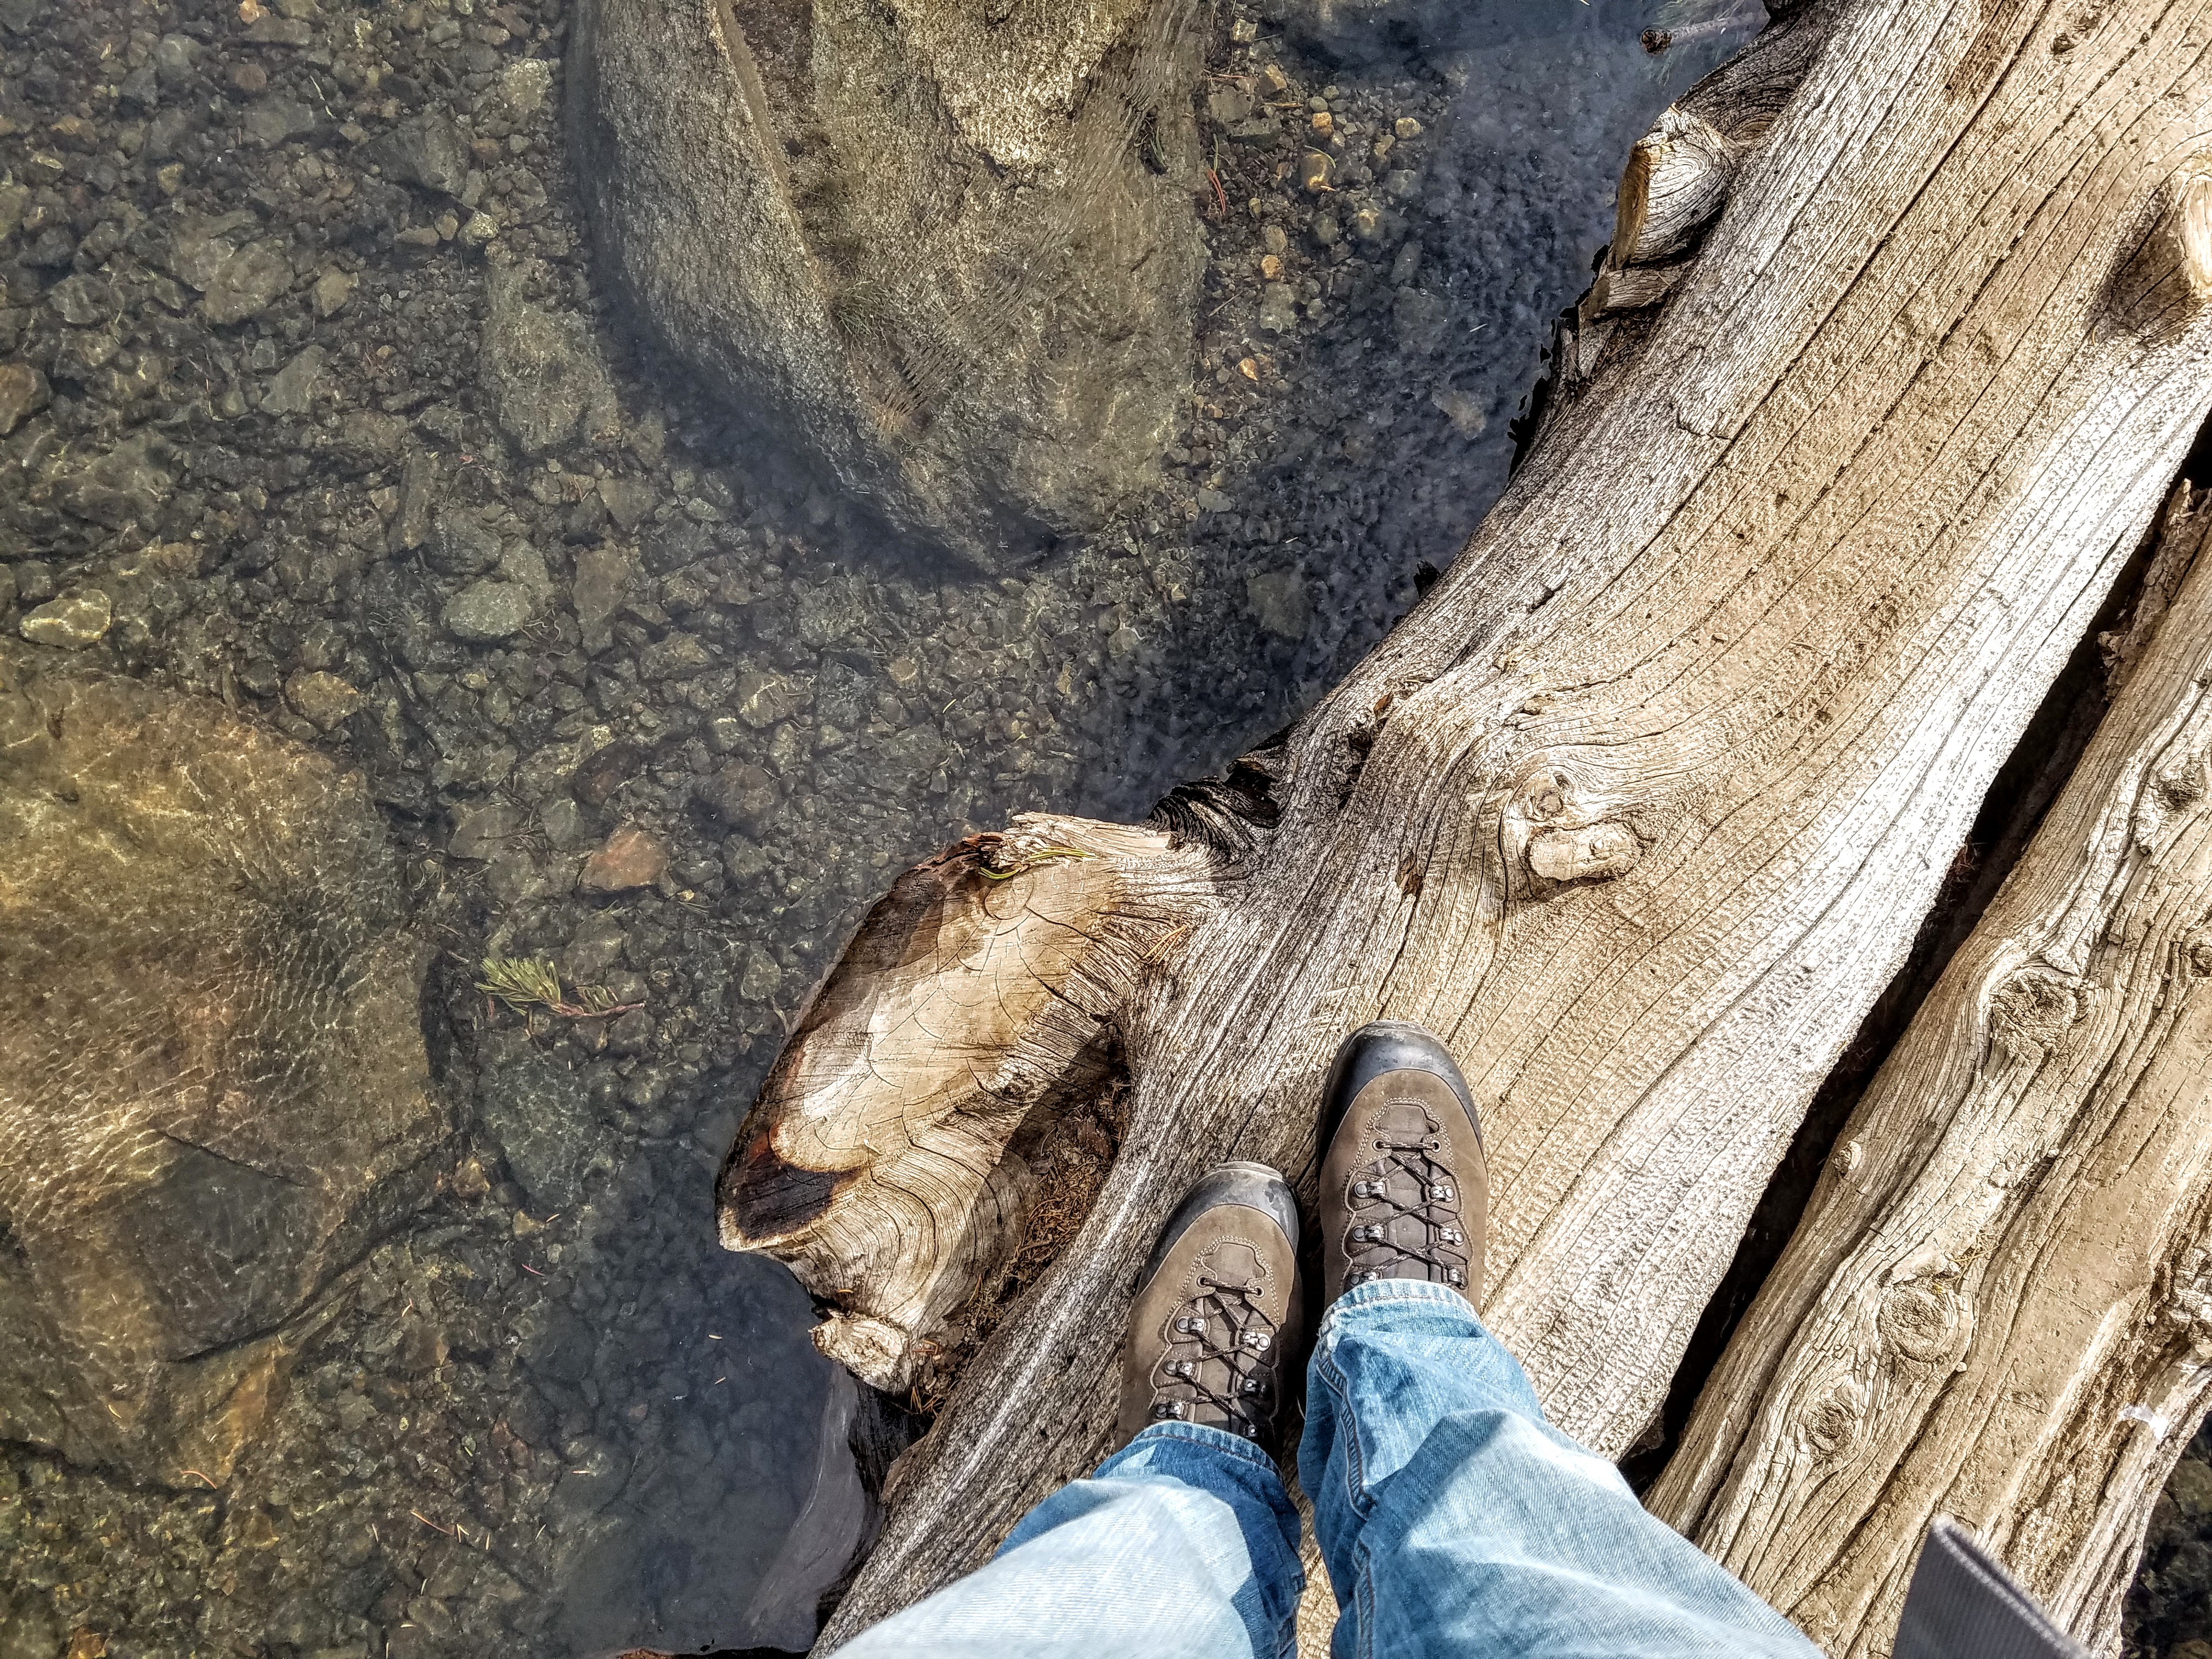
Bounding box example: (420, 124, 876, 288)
(1652, 487, 2212, 1655)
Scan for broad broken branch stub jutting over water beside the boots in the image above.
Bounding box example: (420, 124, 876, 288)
(721, 814, 1212, 1393)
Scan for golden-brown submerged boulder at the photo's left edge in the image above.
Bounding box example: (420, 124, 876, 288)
(0, 657, 444, 1487)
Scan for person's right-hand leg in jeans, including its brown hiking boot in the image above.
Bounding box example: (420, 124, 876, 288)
(1299, 1024, 1818, 1659)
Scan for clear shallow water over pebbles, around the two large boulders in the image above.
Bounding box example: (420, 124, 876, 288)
(0, 0, 1750, 1659)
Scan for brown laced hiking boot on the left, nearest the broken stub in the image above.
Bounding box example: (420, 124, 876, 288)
(1115, 1164, 1303, 1453)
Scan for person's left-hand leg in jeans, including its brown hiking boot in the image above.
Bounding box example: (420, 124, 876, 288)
(838, 1164, 1305, 1659)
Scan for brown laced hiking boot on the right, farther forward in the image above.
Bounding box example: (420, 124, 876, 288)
(1321, 1020, 1491, 1301)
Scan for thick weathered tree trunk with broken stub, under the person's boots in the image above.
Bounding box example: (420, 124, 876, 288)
(723, 0, 2212, 1646)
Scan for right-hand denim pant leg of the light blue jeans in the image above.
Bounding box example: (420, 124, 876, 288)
(1299, 1278, 1818, 1659)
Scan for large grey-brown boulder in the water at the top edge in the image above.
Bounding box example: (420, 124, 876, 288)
(568, 0, 1205, 571)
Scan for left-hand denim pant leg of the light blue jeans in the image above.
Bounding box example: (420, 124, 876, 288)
(838, 1423, 1305, 1659)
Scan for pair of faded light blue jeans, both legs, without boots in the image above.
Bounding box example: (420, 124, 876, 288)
(840, 1278, 1820, 1659)
